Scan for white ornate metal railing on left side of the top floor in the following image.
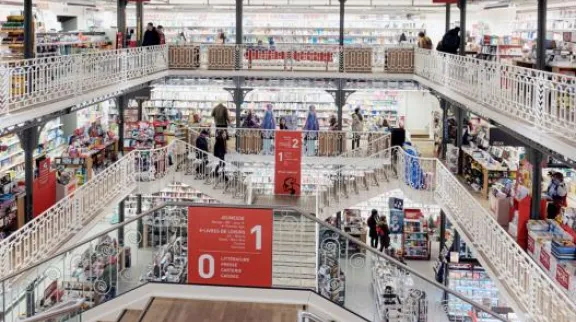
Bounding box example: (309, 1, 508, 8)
(0, 46, 168, 115)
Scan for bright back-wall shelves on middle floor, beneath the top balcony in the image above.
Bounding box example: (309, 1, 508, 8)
(148, 86, 403, 130)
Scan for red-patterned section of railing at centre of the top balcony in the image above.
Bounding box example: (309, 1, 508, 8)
(244, 48, 334, 70)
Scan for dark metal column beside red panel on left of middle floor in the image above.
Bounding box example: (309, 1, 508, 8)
(18, 126, 40, 222)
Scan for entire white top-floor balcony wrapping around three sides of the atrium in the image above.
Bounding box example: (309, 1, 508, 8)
(0, 45, 576, 164)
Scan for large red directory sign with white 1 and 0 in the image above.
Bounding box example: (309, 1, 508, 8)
(188, 207, 273, 287)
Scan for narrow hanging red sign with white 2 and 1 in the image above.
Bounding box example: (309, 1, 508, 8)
(274, 131, 302, 196)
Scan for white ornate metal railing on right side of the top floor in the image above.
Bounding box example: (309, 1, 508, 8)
(414, 49, 576, 140)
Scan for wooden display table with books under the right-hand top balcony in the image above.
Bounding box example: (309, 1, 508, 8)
(462, 146, 516, 198)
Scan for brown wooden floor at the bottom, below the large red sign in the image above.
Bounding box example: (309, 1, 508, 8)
(142, 298, 303, 322)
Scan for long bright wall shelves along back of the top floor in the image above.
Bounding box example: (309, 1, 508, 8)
(128, 11, 425, 45)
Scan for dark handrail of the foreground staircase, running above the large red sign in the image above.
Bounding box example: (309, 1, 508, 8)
(0, 202, 508, 322)
